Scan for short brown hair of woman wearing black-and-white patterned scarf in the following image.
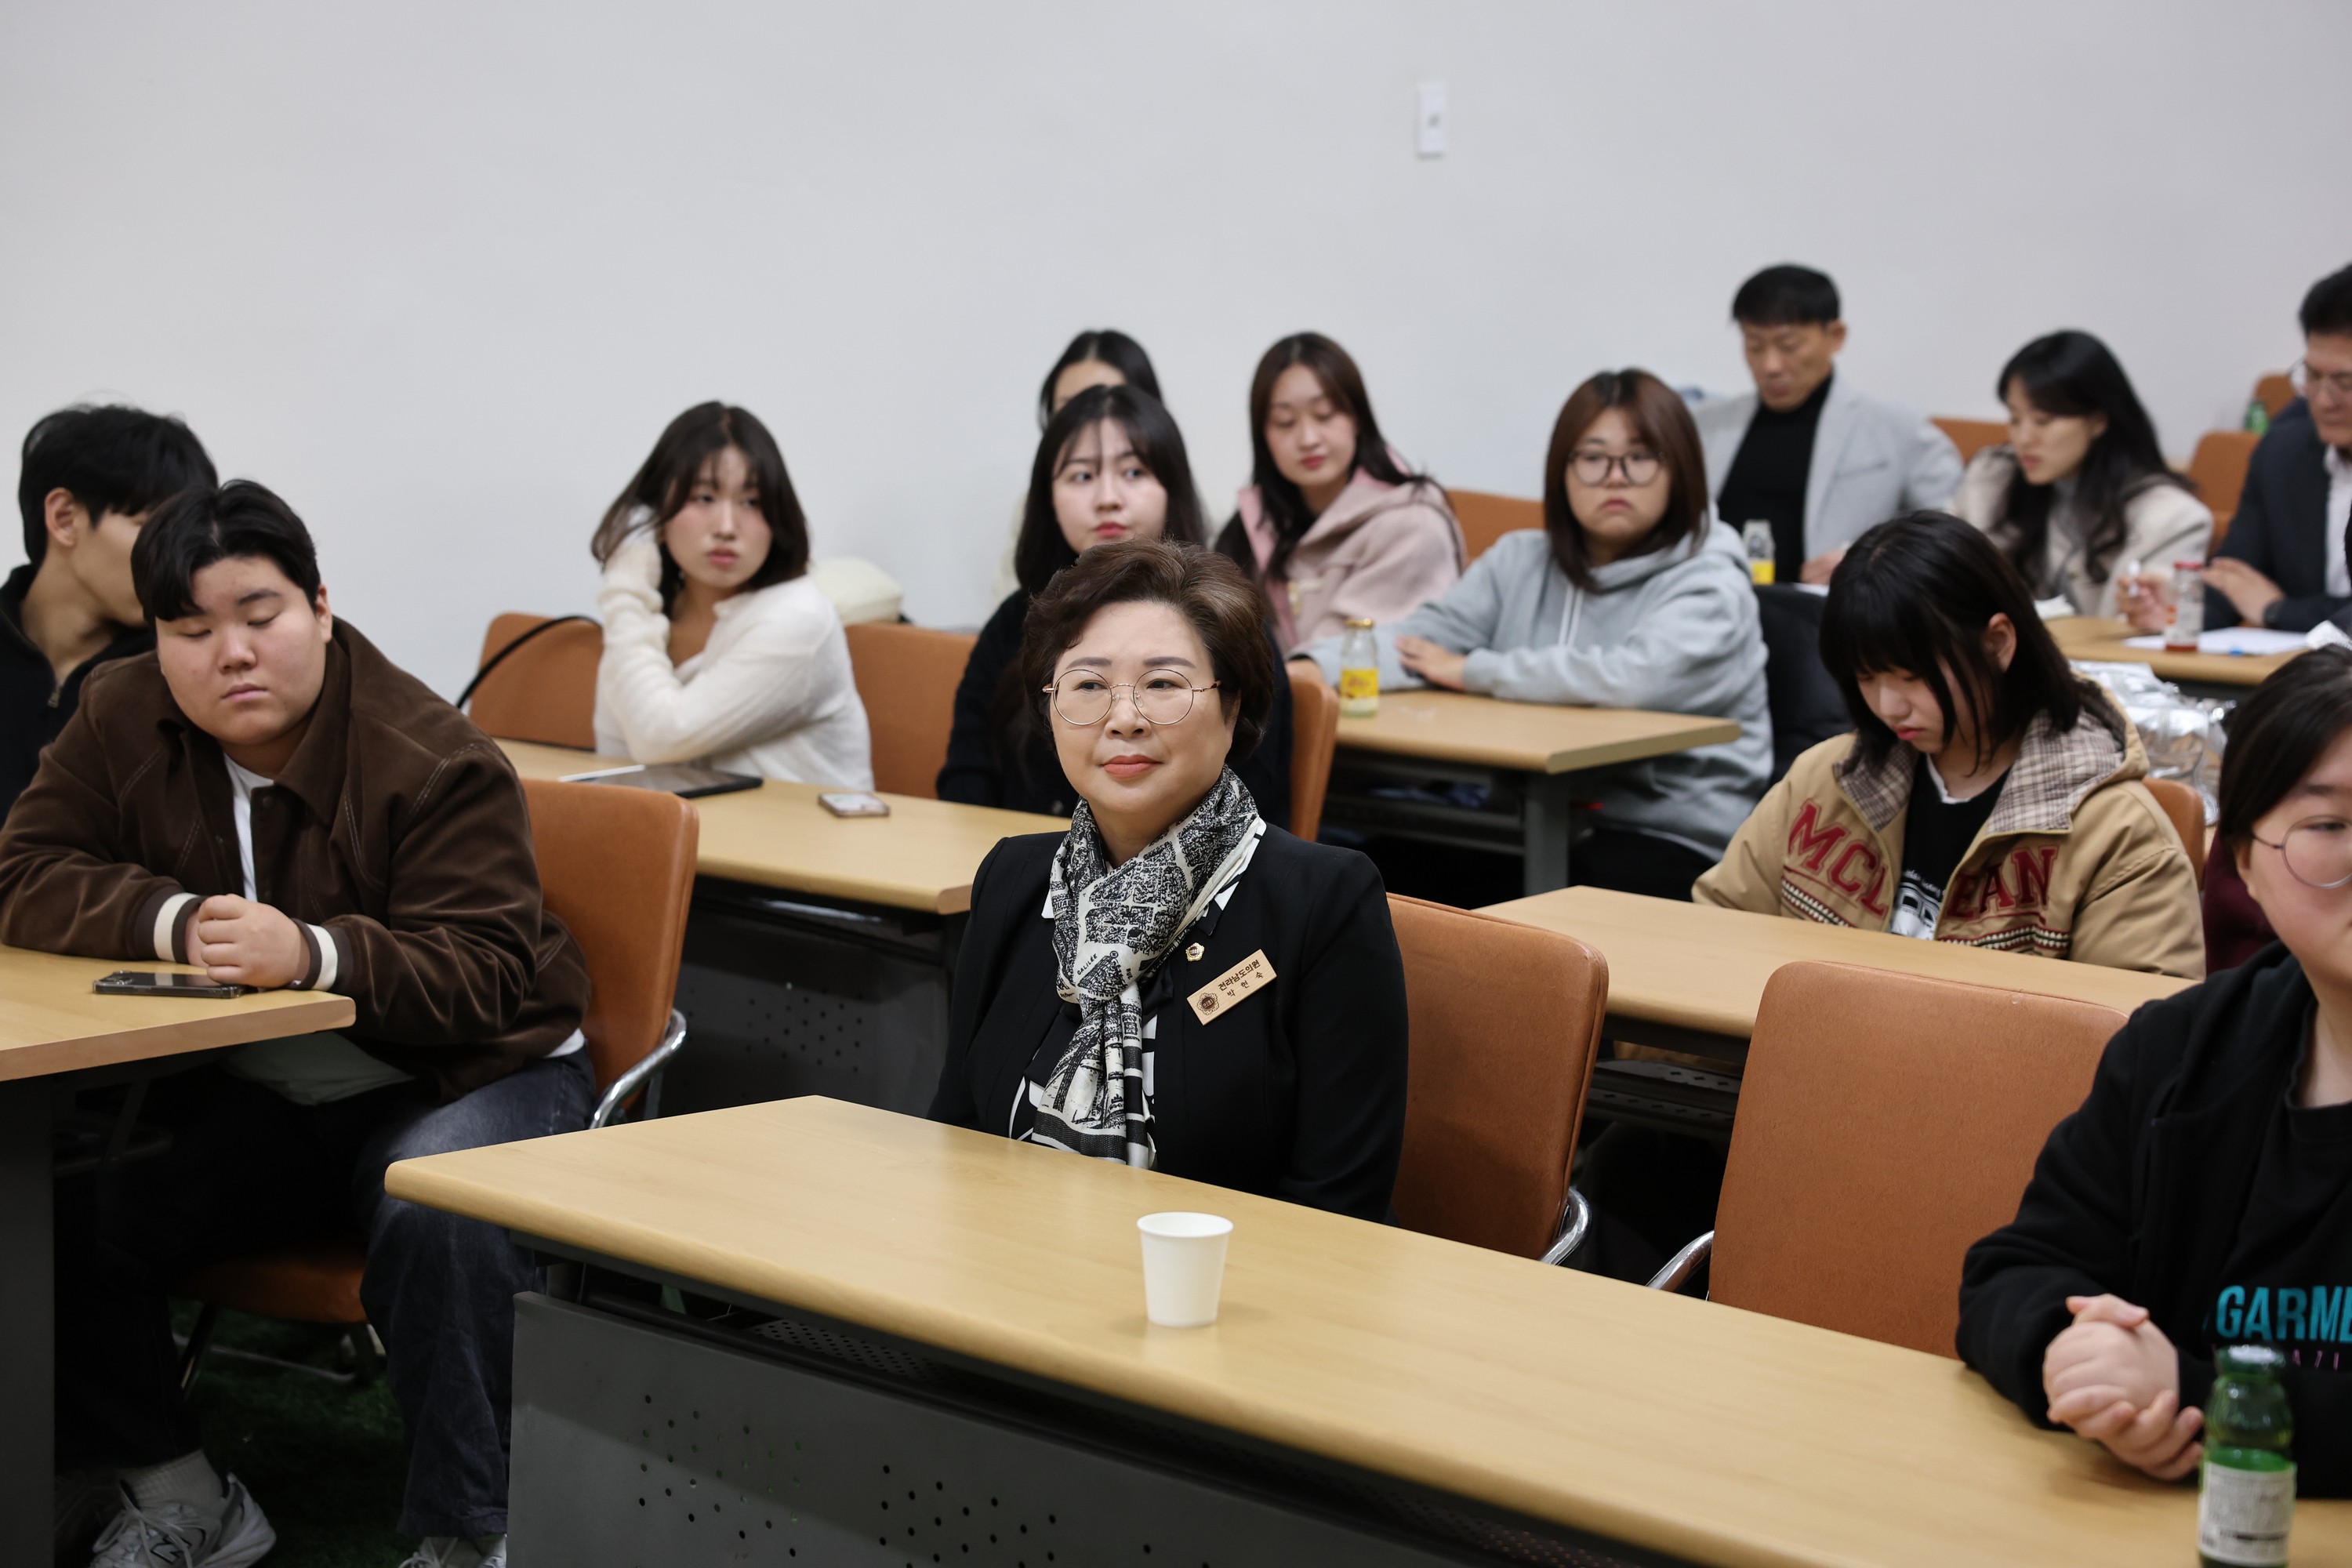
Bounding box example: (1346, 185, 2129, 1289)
(1021, 539, 1282, 767)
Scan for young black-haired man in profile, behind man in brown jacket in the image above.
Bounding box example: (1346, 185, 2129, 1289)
(0, 407, 214, 820)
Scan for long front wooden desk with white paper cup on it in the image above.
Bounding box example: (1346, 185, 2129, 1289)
(386, 1100, 2352, 1568)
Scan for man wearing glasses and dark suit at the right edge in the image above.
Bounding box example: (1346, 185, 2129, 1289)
(2206, 266, 2352, 633)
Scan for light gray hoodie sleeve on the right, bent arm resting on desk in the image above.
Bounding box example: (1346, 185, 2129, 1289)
(1463, 550, 1759, 713)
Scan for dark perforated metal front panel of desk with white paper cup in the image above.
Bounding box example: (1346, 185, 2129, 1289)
(510, 1295, 1684, 1568)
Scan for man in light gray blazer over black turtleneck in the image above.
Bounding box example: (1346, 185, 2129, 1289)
(1691, 266, 1959, 583)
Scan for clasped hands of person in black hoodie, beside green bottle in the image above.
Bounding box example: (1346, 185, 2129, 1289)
(2042, 1295, 2204, 1481)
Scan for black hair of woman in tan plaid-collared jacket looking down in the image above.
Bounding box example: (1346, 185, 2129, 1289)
(1820, 513, 2084, 767)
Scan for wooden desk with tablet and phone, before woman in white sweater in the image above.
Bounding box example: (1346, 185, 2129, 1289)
(499, 741, 1068, 1112)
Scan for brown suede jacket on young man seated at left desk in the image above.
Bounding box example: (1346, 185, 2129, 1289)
(0, 621, 588, 1100)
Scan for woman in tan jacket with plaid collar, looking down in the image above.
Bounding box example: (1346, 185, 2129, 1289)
(1691, 513, 2204, 980)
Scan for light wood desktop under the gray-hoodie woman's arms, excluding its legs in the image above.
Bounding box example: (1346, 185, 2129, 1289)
(1338, 691, 1740, 774)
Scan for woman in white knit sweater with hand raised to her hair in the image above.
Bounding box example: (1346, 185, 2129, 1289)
(590, 402, 873, 789)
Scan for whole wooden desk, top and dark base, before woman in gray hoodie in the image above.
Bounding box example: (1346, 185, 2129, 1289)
(1324, 691, 1740, 893)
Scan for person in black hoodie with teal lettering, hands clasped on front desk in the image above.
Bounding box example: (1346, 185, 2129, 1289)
(1957, 649, 2352, 1497)
